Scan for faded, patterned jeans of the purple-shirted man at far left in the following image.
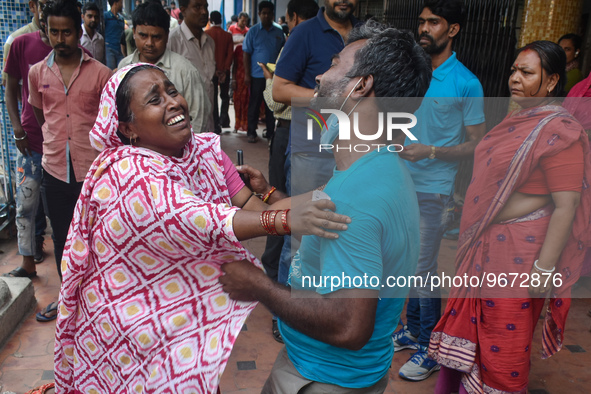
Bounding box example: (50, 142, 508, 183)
(16, 151, 45, 256)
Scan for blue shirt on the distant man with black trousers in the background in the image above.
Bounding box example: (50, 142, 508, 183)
(242, 23, 285, 78)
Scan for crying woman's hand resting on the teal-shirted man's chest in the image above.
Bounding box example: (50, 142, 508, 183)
(290, 200, 351, 239)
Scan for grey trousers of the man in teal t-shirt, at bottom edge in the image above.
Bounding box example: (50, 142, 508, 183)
(261, 346, 389, 394)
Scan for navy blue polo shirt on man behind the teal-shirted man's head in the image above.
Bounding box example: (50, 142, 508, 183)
(275, 7, 361, 153)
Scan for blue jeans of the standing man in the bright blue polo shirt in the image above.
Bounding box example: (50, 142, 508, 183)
(406, 192, 454, 347)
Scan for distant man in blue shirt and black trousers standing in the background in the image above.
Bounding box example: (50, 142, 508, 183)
(242, 1, 285, 142)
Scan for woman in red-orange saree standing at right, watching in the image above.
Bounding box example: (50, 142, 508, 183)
(429, 41, 591, 393)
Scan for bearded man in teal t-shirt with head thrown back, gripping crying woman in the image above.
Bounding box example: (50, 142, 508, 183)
(220, 21, 431, 394)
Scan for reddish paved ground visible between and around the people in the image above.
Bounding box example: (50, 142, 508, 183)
(0, 124, 591, 394)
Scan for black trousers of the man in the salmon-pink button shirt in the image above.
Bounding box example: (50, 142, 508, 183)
(41, 165, 84, 280)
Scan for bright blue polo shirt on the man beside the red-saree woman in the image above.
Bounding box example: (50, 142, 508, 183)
(405, 52, 484, 195)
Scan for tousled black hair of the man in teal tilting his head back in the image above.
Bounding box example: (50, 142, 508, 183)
(345, 20, 431, 101)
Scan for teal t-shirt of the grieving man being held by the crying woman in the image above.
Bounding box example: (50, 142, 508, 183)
(279, 150, 420, 388)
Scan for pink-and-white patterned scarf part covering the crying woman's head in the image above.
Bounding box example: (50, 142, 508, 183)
(90, 63, 164, 152)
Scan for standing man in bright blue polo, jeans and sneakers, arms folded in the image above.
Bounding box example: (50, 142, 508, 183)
(393, 0, 486, 381)
